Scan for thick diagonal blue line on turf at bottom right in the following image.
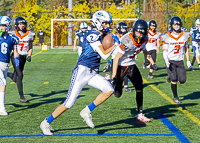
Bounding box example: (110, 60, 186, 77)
(156, 114, 190, 143)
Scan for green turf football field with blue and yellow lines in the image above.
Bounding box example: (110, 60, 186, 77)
(0, 49, 200, 143)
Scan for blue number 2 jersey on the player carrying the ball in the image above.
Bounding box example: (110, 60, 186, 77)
(77, 29, 103, 69)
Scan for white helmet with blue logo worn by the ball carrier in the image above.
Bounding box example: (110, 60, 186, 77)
(92, 10, 112, 32)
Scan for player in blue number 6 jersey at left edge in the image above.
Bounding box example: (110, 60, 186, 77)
(0, 16, 19, 115)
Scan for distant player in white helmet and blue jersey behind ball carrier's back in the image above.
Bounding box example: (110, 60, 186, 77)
(73, 22, 88, 56)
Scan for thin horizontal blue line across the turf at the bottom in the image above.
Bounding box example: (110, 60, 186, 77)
(0, 134, 175, 137)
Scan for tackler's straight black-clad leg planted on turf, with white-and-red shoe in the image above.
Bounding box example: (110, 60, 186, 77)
(127, 65, 151, 122)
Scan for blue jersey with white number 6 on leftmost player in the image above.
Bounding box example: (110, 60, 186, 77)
(0, 34, 19, 63)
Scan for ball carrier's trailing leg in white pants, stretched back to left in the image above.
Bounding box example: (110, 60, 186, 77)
(40, 66, 91, 135)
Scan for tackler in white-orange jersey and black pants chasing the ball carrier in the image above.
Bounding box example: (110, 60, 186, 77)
(111, 19, 158, 122)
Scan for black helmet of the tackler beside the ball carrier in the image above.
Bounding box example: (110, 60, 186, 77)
(132, 19, 148, 43)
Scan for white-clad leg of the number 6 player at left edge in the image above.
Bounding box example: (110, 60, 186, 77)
(0, 62, 9, 115)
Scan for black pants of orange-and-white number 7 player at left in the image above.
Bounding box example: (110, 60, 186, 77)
(11, 54, 26, 99)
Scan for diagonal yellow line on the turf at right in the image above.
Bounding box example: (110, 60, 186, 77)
(143, 78, 200, 126)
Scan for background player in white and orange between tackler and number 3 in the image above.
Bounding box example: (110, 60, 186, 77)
(144, 20, 161, 78)
